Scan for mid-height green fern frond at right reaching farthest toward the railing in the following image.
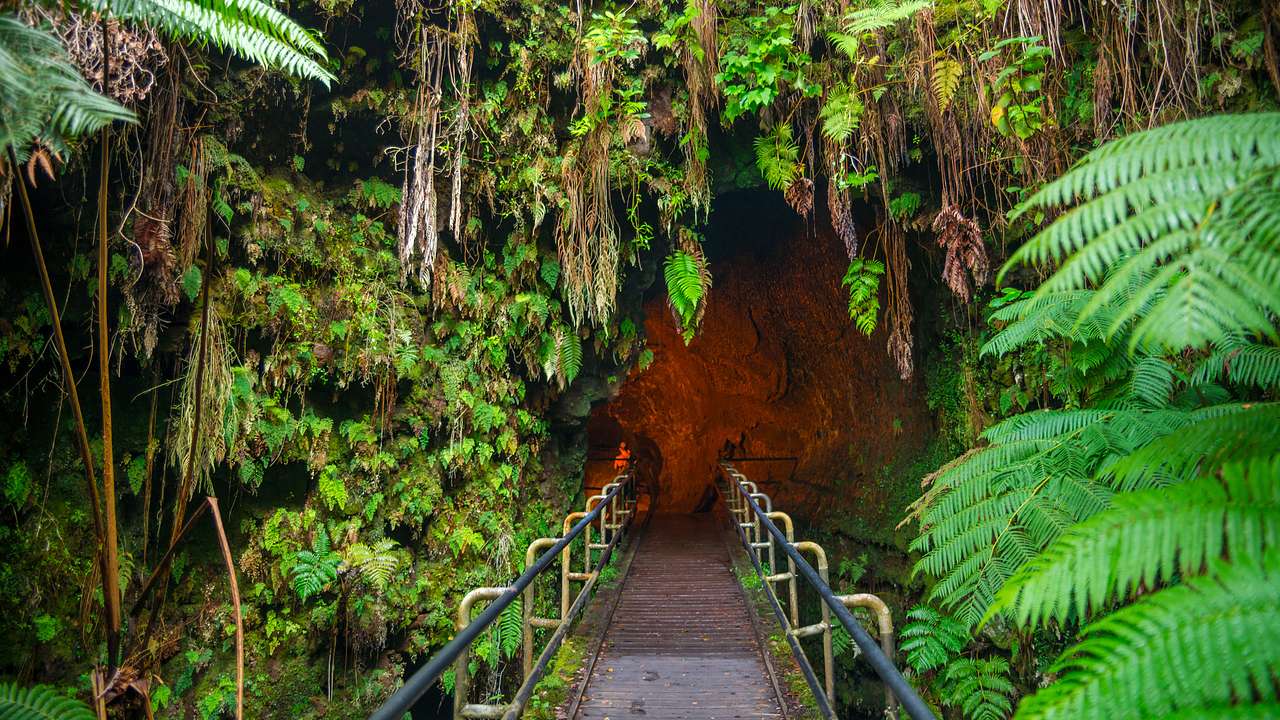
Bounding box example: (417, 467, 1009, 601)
(909, 409, 1204, 625)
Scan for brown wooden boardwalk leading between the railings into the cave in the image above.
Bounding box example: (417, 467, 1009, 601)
(575, 515, 782, 720)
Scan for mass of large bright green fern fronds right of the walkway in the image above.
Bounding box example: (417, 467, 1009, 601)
(909, 114, 1280, 717)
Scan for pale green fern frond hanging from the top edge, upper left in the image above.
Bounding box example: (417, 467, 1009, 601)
(97, 0, 335, 86)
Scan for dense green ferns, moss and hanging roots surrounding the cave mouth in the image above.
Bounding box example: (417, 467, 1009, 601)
(0, 0, 1280, 719)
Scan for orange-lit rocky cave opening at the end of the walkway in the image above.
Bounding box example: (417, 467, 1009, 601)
(588, 191, 931, 514)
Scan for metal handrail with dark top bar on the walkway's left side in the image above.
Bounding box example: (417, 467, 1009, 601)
(369, 468, 632, 720)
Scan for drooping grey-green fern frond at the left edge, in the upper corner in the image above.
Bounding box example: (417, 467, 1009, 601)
(0, 15, 137, 163)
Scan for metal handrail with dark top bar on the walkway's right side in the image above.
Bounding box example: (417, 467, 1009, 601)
(721, 462, 936, 720)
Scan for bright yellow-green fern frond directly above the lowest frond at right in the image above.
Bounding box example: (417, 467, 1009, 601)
(988, 459, 1280, 625)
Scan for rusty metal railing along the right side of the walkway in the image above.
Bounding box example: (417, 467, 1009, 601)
(717, 462, 934, 720)
